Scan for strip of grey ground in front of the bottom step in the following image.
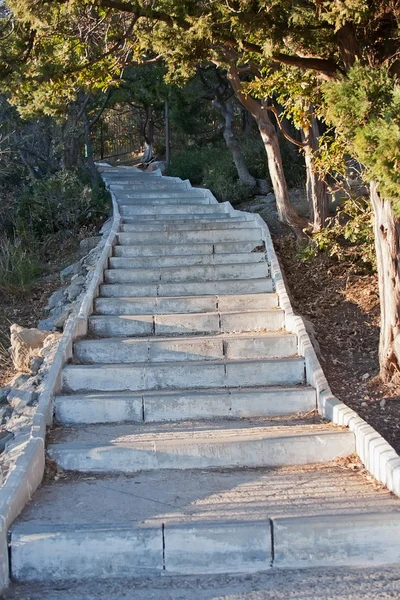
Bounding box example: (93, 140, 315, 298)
(2, 567, 400, 600)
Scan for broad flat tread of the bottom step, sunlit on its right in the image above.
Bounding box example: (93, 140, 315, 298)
(13, 464, 399, 535)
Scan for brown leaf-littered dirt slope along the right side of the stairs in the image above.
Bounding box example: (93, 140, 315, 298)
(274, 235, 400, 452)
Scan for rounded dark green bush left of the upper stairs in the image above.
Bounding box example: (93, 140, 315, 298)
(16, 171, 110, 240)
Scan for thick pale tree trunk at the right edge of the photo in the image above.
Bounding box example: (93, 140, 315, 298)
(371, 182, 400, 382)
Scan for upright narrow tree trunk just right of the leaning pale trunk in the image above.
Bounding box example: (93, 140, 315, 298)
(302, 117, 329, 231)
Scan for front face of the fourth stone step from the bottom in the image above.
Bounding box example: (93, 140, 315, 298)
(62, 358, 304, 393)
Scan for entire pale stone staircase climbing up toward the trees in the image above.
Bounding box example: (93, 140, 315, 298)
(0, 166, 400, 587)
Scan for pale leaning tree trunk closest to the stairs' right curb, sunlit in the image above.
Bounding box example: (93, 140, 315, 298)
(229, 68, 308, 241)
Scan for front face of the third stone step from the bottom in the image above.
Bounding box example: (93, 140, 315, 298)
(54, 386, 316, 426)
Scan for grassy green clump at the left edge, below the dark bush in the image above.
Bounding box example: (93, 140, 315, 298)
(0, 235, 40, 289)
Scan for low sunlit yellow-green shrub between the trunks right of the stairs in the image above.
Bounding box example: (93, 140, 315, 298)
(301, 196, 376, 271)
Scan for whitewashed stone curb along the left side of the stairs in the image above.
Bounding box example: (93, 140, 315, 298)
(0, 164, 136, 593)
